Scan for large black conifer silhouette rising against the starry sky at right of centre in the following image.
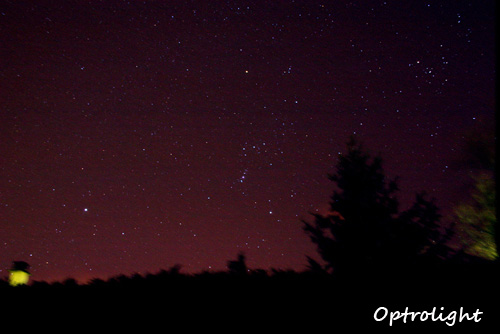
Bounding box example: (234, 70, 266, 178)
(303, 137, 448, 275)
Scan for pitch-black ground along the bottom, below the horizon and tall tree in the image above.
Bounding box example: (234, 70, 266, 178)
(0, 263, 500, 333)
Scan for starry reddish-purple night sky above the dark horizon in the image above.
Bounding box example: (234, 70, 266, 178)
(0, 0, 495, 281)
